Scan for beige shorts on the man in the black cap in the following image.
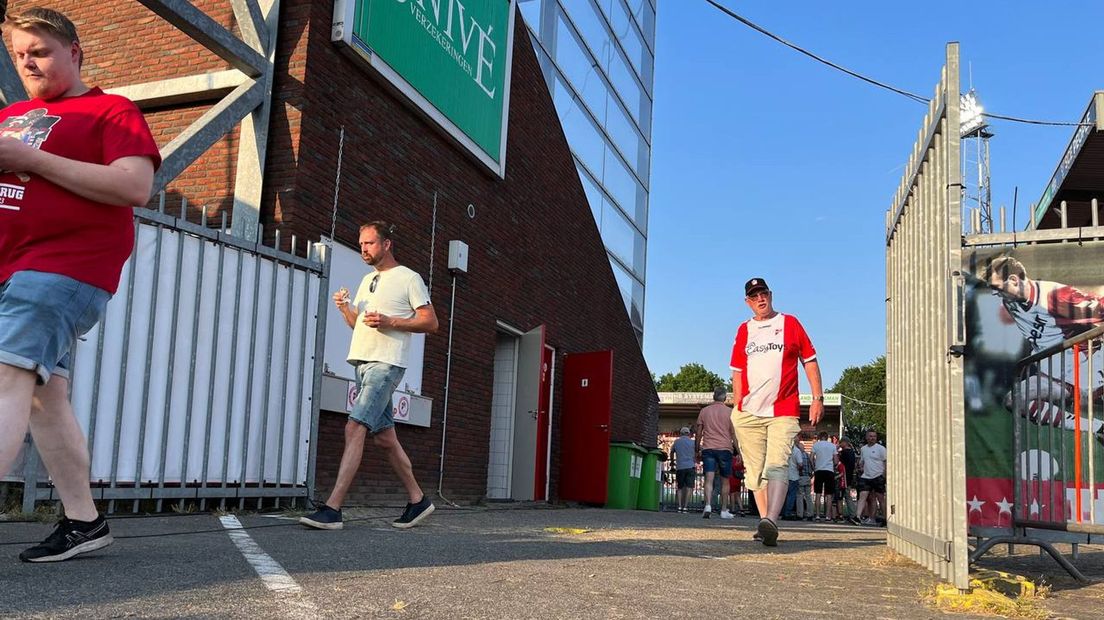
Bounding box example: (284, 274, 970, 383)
(732, 410, 802, 491)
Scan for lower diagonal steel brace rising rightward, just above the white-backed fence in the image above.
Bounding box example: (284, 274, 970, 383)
(152, 81, 265, 194)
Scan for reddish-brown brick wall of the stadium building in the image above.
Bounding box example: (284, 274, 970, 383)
(12, 0, 658, 503)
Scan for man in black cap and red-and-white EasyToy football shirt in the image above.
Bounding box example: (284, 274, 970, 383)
(730, 278, 824, 547)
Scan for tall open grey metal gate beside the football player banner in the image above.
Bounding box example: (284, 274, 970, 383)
(885, 43, 969, 588)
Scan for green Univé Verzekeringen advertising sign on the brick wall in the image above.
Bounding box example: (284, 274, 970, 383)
(332, 0, 514, 175)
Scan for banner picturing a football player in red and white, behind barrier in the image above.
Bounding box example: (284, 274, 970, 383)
(963, 243, 1104, 527)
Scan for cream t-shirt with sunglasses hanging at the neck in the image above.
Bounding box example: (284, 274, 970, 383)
(348, 265, 429, 368)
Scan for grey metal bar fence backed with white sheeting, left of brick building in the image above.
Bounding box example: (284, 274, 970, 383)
(12, 193, 329, 512)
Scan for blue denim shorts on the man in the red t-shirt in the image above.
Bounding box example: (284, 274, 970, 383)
(0, 271, 112, 385)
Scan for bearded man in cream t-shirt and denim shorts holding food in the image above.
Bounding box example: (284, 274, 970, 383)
(299, 222, 437, 530)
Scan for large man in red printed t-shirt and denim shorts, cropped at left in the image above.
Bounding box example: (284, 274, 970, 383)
(0, 9, 161, 562)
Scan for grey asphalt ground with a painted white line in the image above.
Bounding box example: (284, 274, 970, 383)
(0, 507, 1104, 619)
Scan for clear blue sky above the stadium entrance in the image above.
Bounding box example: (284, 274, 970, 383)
(644, 0, 1104, 387)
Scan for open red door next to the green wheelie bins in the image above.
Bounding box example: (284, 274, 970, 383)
(560, 351, 614, 504)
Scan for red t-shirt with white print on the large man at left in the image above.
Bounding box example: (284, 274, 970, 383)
(0, 88, 161, 295)
